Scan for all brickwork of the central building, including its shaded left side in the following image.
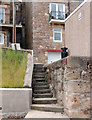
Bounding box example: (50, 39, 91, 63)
(26, 0, 83, 63)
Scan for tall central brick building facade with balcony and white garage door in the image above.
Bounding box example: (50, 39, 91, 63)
(26, 0, 81, 63)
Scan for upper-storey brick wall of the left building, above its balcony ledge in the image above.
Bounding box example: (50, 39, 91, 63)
(0, 2, 25, 24)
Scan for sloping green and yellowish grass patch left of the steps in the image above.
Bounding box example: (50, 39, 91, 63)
(0, 50, 27, 88)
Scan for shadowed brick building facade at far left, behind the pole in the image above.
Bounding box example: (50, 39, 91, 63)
(0, 2, 25, 47)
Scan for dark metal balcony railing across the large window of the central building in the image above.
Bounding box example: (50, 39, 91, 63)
(49, 11, 69, 20)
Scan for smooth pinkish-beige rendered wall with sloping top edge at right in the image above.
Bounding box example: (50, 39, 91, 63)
(65, 2, 90, 56)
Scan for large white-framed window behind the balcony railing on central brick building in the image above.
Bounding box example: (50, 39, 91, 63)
(50, 3, 65, 20)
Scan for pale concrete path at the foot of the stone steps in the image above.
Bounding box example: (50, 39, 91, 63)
(25, 110, 69, 120)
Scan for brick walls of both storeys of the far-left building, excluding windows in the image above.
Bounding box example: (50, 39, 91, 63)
(0, 2, 25, 47)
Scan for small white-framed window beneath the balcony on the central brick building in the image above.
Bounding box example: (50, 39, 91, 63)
(53, 28, 62, 42)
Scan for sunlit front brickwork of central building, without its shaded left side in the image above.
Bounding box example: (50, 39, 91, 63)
(33, 2, 65, 63)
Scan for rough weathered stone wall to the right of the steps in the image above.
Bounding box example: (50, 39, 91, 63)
(45, 57, 92, 118)
